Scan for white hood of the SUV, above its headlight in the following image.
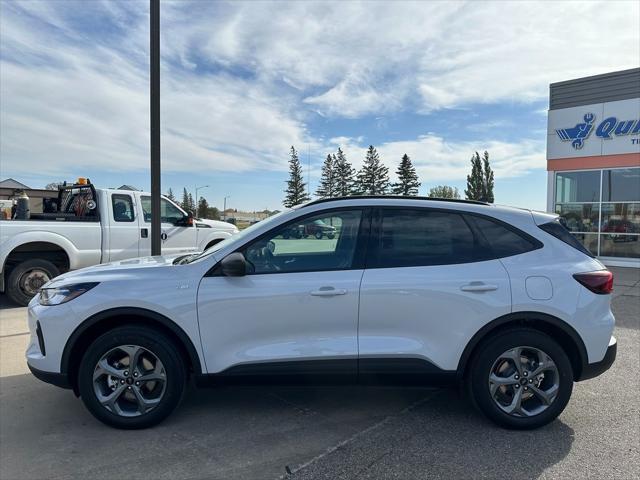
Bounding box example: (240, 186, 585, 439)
(44, 254, 184, 288)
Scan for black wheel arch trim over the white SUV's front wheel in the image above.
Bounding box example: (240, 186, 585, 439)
(60, 307, 202, 395)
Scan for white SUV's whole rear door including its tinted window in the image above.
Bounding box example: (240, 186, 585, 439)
(358, 208, 511, 375)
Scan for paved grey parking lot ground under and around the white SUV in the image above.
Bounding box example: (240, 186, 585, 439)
(0, 269, 640, 480)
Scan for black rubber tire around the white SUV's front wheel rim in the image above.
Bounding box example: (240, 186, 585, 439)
(78, 326, 187, 430)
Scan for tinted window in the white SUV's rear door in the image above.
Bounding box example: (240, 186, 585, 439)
(368, 209, 476, 268)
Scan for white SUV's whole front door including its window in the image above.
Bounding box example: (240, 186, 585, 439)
(198, 209, 368, 379)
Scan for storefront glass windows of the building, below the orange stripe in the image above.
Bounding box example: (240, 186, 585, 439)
(555, 168, 640, 259)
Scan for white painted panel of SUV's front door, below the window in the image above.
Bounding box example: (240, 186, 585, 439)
(198, 270, 363, 373)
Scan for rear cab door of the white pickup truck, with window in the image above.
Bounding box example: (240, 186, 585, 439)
(107, 193, 140, 261)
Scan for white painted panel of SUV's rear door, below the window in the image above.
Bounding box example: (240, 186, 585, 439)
(358, 260, 511, 370)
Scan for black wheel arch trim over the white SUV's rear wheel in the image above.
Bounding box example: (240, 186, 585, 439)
(457, 312, 588, 381)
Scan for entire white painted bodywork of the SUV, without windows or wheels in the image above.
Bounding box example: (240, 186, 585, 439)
(27, 198, 614, 388)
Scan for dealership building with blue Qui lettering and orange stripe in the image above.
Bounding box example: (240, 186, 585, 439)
(547, 68, 640, 267)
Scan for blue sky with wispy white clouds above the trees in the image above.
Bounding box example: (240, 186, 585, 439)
(0, 0, 640, 210)
